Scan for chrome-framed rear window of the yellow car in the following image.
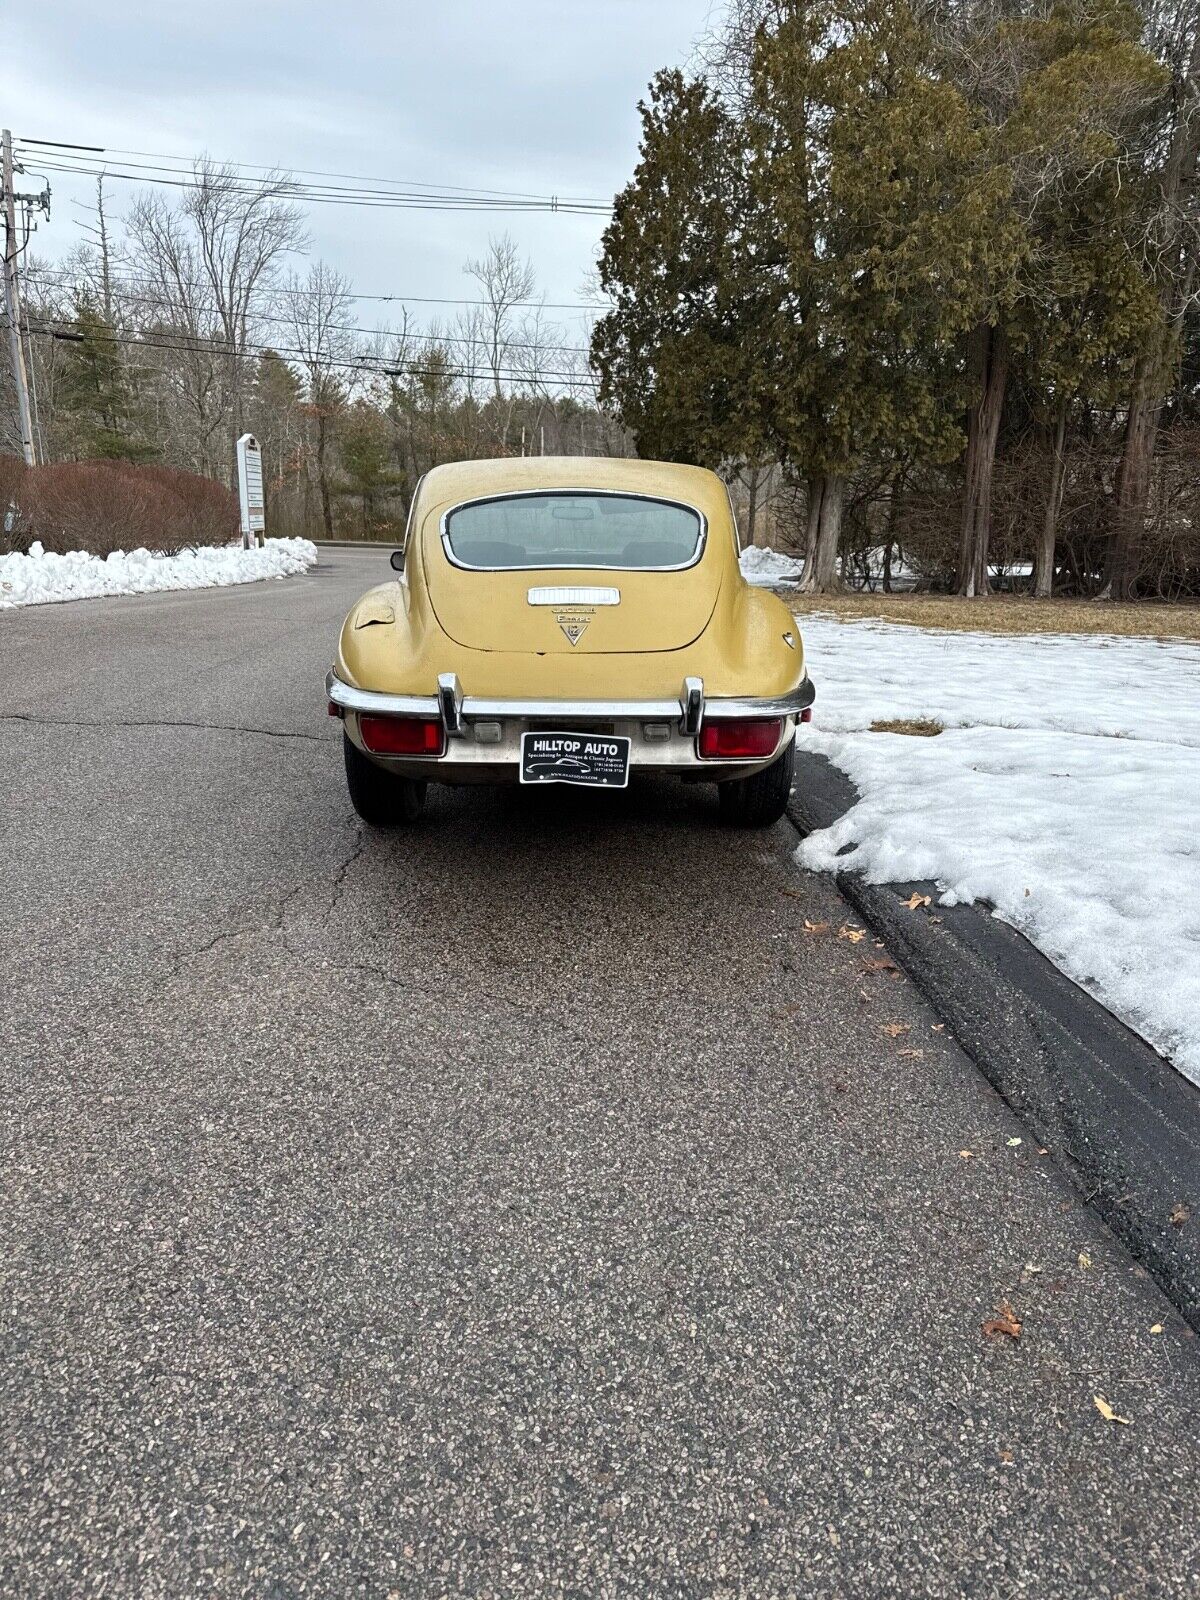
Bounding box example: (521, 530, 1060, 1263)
(442, 491, 704, 571)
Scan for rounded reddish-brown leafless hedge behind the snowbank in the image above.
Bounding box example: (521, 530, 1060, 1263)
(19, 461, 238, 555)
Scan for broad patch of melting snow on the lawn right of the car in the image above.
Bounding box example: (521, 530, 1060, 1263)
(797, 616, 1200, 1083)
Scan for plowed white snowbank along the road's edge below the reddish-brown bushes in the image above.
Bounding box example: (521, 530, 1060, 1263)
(0, 539, 317, 610)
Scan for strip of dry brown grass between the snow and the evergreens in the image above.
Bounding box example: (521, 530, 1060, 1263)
(784, 590, 1200, 643)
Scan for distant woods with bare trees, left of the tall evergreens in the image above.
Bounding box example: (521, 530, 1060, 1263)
(0, 176, 630, 546)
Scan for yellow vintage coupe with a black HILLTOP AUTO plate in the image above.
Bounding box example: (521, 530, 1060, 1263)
(325, 456, 814, 827)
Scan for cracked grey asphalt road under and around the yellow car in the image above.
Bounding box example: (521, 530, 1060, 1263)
(0, 552, 1200, 1600)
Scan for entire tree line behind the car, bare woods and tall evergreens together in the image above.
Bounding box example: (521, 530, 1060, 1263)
(0, 0, 1200, 598)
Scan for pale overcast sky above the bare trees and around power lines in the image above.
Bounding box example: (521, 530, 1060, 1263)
(9, 0, 714, 345)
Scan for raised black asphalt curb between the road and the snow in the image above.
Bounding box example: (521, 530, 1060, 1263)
(789, 755, 1200, 1333)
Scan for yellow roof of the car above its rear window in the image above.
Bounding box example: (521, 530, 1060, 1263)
(421, 456, 728, 515)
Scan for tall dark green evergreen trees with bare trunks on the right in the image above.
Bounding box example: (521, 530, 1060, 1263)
(592, 0, 1200, 597)
